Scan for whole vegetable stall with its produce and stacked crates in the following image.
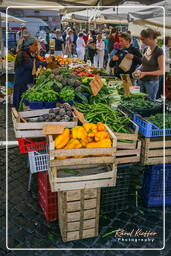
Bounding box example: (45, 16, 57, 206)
(12, 54, 171, 242)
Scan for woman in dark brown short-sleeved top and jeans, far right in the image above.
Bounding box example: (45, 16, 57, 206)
(138, 28, 164, 100)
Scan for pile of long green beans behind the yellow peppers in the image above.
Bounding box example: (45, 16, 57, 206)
(75, 103, 130, 133)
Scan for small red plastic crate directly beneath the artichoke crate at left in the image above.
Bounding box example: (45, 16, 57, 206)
(18, 138, 46, 153)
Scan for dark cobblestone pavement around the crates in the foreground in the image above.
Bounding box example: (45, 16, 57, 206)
(0, 104, 171, 256)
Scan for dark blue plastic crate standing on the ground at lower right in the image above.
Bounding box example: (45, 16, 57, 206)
(140, 164, 171, 207)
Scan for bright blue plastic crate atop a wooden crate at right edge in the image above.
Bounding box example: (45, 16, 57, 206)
(133, 114, 171, 137)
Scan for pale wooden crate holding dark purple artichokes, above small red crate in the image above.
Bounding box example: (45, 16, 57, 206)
(12, 108, 78, 138)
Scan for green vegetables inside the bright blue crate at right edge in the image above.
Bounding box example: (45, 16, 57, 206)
(145, 113, 171, 129)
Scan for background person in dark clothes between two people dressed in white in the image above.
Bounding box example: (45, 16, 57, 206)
(87, 30, 96, 64)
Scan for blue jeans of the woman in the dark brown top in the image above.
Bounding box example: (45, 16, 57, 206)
(138, 80, 159, 100)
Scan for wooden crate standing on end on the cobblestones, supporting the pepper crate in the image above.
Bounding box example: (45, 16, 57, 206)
(58, 188, 100, 242)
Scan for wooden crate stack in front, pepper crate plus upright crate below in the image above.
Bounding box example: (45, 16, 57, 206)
(48, 126, 117, 242)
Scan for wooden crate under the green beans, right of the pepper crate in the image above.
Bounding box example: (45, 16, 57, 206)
(116, 140, 141, 164)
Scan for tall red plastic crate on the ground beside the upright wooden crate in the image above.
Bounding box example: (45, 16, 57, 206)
(38, 172, 58, 221)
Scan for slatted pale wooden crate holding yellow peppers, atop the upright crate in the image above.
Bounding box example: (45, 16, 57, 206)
(48, 126, 116, 192)
